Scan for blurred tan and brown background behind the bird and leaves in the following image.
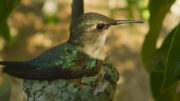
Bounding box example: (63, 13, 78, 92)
(0, 0, 180, 101)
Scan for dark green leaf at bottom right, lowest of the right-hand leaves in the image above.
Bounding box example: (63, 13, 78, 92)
(150, 72, 177, 101)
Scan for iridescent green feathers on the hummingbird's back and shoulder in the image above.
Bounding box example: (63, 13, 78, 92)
(26, 43, 96, 69)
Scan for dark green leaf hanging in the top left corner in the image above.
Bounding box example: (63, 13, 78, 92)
(0, 0, 20, 43)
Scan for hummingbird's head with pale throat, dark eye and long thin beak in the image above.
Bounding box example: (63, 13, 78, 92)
(69, 13, 142, 58)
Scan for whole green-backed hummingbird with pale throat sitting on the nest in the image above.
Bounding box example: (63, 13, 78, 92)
(0, 13, 142, 80)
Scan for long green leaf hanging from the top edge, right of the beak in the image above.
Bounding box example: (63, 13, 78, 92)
(142, 0, 175, 67)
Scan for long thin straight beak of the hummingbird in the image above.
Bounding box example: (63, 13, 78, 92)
(111, 20, 144, 25)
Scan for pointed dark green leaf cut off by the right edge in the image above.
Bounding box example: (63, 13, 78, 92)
(162, 24, 180, 91)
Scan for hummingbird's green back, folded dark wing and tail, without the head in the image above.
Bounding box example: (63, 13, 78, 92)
(0, 43, 100, 80)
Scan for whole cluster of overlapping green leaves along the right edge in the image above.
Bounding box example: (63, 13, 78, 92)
(142, 0, 180, 101)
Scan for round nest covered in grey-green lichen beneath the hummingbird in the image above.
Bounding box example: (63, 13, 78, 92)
(22, 62, 119, 101)
